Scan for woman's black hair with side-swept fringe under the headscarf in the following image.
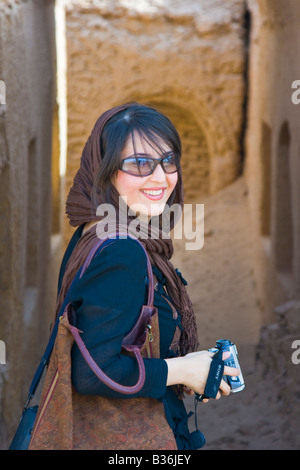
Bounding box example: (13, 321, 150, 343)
(92, 103, 181, 206)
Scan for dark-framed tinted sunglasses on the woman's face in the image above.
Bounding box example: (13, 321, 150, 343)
(120, 153, 179, 176)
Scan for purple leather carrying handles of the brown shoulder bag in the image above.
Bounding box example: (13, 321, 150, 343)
(61, 234, 157, 395)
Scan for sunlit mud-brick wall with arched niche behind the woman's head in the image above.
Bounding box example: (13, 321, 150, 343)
(62, 0, 245, 242)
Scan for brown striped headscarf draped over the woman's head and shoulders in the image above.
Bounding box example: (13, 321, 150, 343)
(57, 104, 198, 396)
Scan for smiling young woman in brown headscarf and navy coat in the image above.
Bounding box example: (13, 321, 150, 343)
(31, 103, 239, 450)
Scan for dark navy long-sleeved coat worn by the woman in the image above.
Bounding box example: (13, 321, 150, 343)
(58, 226, 203, 449)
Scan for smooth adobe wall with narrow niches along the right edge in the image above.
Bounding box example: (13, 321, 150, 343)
(245, 0, 300, 322)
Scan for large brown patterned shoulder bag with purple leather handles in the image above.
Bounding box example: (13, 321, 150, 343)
(29, 240, 177, 450)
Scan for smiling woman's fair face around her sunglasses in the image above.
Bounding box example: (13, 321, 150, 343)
(113, 134, 178, 221)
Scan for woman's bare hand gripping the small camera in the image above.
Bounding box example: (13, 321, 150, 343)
(165, 351, 240, 402)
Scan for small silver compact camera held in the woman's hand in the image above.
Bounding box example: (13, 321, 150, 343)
(209, 339, 245, 393)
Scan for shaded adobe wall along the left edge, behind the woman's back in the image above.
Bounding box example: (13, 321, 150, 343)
(0, 0, 57, 448)
